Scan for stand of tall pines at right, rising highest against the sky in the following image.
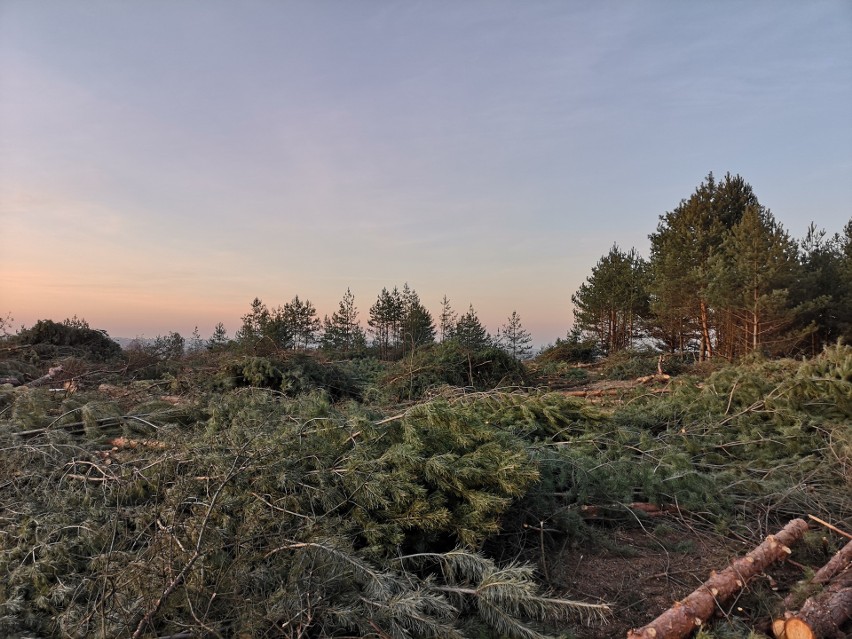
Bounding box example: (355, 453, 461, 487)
(572, 173, 852, 360)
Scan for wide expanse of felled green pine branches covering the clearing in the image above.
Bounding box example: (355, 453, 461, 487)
(0, 345, 852, 639)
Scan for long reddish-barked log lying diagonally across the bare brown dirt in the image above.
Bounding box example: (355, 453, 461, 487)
(627, 519, 808, 639)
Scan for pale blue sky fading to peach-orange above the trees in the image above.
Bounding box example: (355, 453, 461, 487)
(0, 0, 852, 345)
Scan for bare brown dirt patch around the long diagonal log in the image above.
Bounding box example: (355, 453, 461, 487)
(539, 517, 831, 639)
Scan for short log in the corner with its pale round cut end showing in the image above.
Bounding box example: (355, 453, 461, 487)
(772, 566, 852, 639)
